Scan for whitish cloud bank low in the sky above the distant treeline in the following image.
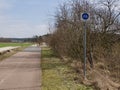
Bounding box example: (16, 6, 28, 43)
(0, 20, 49, 38)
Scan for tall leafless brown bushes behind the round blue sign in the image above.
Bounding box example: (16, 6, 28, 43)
(49, 0, 120, 82)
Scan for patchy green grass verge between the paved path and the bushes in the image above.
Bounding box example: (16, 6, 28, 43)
(41, 47, 93, 90)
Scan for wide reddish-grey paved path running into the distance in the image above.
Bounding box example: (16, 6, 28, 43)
(0, 46, 41, 90)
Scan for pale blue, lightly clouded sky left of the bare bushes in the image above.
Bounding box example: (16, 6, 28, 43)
(0, 0, 65, 38)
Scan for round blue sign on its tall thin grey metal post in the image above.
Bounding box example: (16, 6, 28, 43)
(81, 13, 90, 79)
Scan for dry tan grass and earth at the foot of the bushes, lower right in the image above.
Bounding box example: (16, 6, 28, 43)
(71, 61, 120, 90)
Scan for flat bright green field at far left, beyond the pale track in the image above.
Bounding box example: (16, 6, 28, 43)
(0, 42, 31, 47)
